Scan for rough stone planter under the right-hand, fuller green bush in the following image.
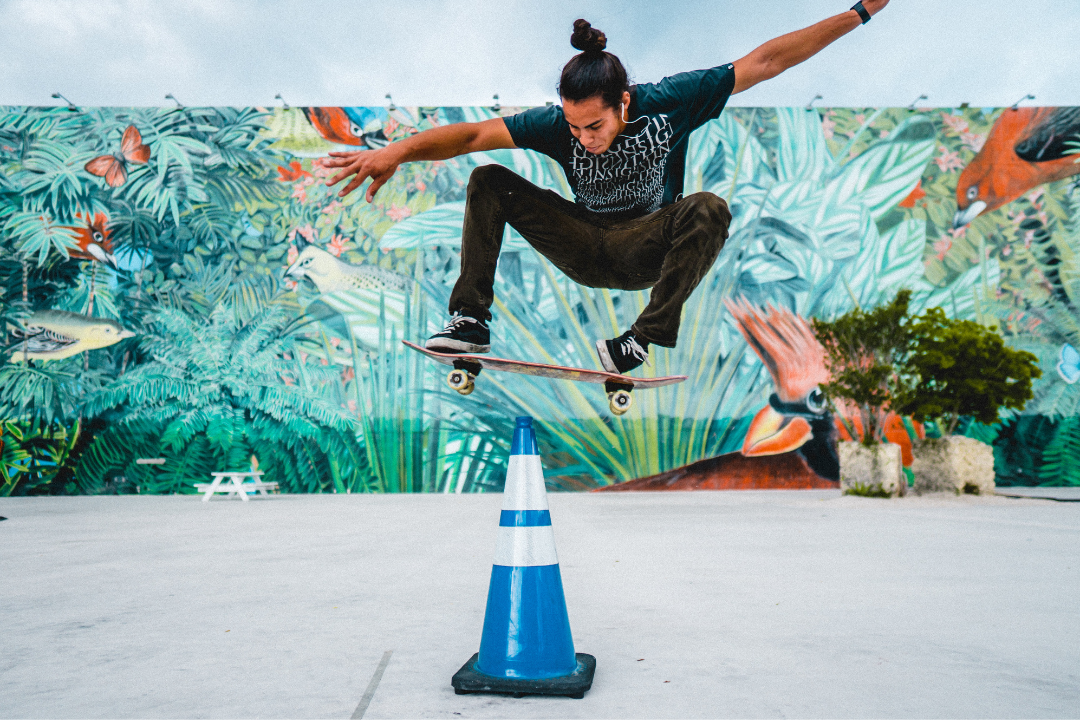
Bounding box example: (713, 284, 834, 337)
(912, 435, 996, 495)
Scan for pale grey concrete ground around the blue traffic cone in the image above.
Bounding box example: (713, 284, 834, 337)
(0, 491, 1080, 718)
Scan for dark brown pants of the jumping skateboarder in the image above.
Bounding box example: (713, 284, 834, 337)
(442, 165, 731, 348)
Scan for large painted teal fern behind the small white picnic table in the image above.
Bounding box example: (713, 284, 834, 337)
(80, 304, 368, 492)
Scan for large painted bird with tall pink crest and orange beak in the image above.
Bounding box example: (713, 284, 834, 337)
(600, 299, 840, 491)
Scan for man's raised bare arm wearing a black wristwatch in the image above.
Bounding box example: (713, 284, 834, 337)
(731, 0, 889, 94)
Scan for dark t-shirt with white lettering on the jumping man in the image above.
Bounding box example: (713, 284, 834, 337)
(503, 65, 735, 217)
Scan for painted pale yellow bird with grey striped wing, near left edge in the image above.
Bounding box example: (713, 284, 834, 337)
(9, 310, 135, 363)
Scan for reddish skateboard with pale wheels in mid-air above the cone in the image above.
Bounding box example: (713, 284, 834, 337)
(402, 340, 686, 415)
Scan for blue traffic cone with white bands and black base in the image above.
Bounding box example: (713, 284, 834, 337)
(451, 417, 596, 697)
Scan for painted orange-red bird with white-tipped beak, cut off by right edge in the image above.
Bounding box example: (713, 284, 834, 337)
(953, 107, 1080, 229)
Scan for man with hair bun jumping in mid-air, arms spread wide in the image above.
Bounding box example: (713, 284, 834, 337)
(324, 0, 889, 372)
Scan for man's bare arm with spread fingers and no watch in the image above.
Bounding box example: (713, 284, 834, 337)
(323, 118, 517, 202)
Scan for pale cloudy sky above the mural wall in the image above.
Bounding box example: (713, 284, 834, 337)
(0, 0, 1080, 107)
